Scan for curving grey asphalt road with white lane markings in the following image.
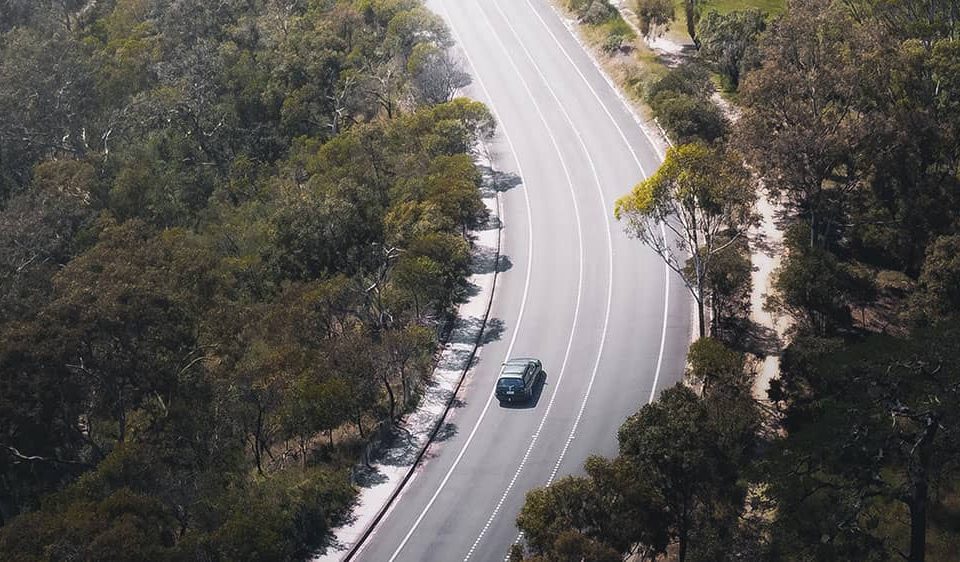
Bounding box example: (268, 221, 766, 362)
(356, 0, 690, 562)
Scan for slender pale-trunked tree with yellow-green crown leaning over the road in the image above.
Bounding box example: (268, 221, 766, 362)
(614, 144, 755, 337)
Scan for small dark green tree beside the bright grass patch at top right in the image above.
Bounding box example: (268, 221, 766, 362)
(697, 10, 767, 90)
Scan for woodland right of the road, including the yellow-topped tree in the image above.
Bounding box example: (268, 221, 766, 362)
(511, 0, 960, 562)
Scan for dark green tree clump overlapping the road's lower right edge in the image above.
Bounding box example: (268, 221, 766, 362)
(517, 372, 758, 560)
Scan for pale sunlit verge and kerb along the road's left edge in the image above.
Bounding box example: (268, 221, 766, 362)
(314, 143, 503, 561)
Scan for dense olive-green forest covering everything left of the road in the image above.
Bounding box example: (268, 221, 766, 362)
(0, 0, 494, 560)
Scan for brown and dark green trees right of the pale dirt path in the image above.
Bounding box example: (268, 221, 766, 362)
(734, 6, 960, 561)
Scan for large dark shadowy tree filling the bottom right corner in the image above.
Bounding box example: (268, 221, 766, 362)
(766, 326, 960, 562)
